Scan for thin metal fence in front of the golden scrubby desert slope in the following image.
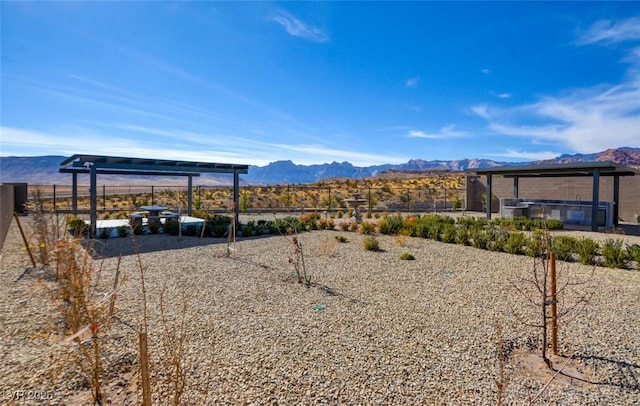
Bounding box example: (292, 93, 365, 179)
(29, 181, 466, 212)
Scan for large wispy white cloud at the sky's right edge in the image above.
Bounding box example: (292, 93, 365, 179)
(470, 18, 640, 153)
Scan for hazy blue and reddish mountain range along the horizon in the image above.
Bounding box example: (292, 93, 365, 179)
(0, 147, 640, 186)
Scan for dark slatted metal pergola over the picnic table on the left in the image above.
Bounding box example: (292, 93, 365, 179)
(59, 154, 249, 236)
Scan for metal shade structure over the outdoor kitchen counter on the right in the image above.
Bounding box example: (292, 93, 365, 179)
(466, 161, 640, 231)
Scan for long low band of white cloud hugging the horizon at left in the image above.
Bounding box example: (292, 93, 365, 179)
(0, 125, 409, 166)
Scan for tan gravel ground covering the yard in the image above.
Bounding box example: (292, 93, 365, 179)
(0, 214, 640, 405)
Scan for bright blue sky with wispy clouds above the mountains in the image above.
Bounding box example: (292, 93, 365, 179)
(0, 1, 640, 166)
